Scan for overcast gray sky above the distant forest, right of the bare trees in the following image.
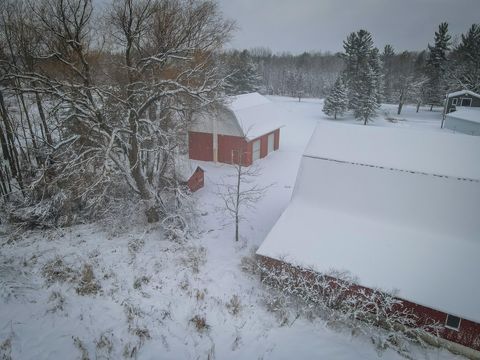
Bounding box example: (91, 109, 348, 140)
(218, 0, 480, 53)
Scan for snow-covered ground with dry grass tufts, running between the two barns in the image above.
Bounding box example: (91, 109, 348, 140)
(0, 97, 464, 359)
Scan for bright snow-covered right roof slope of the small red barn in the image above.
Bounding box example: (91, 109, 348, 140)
(228, 93, 283, 140)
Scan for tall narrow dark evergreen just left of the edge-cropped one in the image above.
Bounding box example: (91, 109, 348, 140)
(424, 22, 451, 110)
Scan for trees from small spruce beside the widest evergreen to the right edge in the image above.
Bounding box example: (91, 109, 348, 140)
(323, 23, 480, 124)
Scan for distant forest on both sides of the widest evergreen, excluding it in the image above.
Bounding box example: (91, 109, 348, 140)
(223, 23, 480, 105)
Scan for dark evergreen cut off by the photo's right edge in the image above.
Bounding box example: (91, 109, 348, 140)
(450, 24, 480, 92)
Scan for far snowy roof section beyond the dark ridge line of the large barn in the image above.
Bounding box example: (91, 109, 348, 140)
(305, 122, 480, 180)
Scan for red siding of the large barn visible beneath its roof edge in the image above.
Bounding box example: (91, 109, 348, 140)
(257, 255, 480, 351)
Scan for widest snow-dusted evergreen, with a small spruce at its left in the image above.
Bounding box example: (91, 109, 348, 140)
(343, 30, 382, 125)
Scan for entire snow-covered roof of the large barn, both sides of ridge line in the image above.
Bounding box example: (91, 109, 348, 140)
(257, 124, 480, 322)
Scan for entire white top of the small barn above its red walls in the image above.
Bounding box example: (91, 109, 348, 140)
(191, 93, 283, 140)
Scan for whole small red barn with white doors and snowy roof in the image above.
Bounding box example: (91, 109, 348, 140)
(188, 93, 282, 166)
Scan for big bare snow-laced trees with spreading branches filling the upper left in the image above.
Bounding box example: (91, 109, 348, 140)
(0, 0, 233, 225)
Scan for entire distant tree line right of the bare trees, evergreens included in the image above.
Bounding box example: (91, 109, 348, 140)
(223, 23, 480, 122)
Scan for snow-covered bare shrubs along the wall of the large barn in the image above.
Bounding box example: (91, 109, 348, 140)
(257, 258, 441, 356)
